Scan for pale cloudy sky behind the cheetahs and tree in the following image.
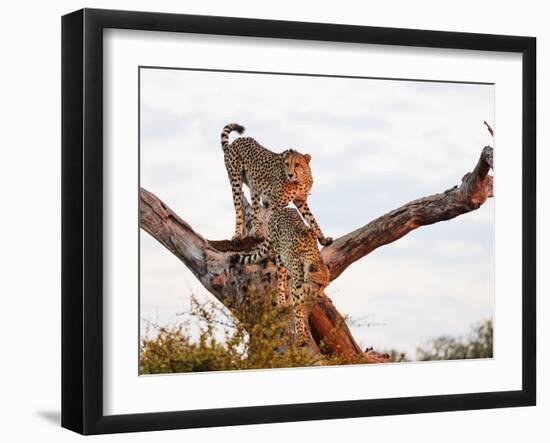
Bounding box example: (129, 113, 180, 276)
(140, 69, 494, 357)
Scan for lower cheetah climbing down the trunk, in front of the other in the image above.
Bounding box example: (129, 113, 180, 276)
(232, 208, 330, 344)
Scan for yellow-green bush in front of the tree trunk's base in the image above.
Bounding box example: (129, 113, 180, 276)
(140, 298, 380, 374)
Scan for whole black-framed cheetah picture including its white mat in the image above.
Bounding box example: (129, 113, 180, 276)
(62, 9, 536, 434)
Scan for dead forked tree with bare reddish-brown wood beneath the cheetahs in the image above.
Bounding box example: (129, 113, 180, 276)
(140, 146, 493, 362)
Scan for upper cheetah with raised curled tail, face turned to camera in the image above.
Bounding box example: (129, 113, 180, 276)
(221, 123, 332, 246)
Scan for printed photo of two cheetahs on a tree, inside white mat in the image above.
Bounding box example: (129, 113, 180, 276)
(138, 66, 495, 375)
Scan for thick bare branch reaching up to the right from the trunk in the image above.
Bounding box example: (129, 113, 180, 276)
(321, 146, 493, 280)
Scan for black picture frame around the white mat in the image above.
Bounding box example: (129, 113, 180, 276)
(62, 9, 536, 434)
